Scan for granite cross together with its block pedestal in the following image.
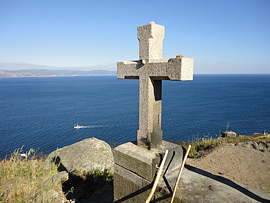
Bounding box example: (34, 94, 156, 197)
(114, 22, 193, 202)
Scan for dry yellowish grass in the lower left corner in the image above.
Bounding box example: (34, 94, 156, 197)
(0, 148, 62, 202)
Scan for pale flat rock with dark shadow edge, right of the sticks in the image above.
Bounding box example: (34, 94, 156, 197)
(169, 165, 270, 203)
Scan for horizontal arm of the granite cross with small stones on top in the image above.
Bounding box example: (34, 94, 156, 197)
(117, 58, 193, 80)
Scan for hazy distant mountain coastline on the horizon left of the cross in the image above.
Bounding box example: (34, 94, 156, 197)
(0, 63, 116, 77)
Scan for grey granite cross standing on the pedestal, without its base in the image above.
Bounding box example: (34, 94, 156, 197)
(117, 22, 193, 149)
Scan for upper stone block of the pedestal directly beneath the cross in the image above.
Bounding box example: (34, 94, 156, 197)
(114, 140, 183, 181)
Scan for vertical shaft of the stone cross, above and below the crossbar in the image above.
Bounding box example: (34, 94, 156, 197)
(137, 22, 165, 148)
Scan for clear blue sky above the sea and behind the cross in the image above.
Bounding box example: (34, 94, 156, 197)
(0, 0, 270, 73)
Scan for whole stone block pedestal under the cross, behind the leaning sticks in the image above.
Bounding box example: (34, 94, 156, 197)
(114, 141, 183, 202)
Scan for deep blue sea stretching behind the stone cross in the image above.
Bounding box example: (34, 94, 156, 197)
(0, 75, 270, 158)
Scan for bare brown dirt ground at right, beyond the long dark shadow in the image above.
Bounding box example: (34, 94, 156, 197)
(186, 144, 270, 193)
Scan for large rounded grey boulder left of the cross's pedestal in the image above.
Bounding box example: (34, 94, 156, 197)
(45, 138, 114, 173)
